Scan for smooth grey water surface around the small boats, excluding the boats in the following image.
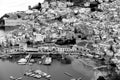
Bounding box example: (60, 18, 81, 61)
(0, 57, 93, 80)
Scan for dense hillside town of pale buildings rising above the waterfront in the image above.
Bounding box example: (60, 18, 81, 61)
(0, 0, 120, 80)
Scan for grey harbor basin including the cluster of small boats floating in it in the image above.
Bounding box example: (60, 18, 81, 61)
(0, 54, 94, 80)
